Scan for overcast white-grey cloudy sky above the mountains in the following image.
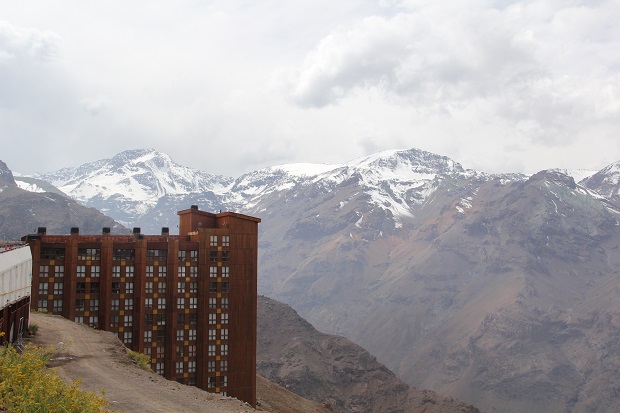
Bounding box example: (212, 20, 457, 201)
(0, 0, 620, 177)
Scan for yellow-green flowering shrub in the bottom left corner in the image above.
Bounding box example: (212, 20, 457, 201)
(0, 344, 109, 413)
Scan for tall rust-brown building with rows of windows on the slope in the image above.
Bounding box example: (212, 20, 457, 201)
(28, 206, 260, 406)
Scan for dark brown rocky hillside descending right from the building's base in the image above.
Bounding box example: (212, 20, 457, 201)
(257, 296, 479, 413)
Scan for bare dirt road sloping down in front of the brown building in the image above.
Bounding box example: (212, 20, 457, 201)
(31, 314, 255, 413)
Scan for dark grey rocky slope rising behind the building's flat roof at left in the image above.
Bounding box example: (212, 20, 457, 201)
(0, 161, 127, 240)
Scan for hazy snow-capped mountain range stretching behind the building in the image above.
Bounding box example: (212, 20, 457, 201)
(4, 149, 620, 412)
